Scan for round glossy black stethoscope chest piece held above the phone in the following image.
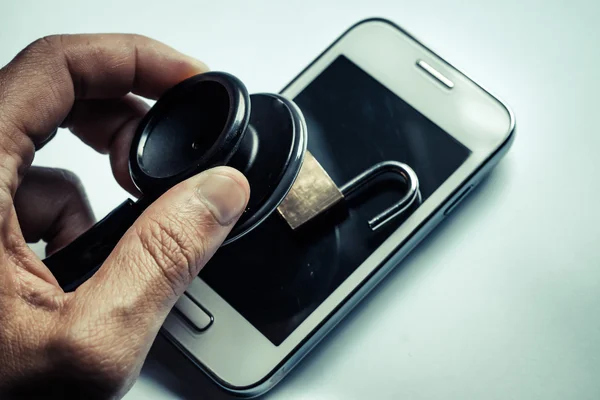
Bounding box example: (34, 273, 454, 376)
(130, 72, 307, 244)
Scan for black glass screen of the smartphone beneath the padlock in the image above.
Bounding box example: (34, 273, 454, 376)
(200, 56, 470, 346)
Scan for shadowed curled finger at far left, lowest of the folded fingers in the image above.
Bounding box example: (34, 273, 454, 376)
(14, 167, 95, 254)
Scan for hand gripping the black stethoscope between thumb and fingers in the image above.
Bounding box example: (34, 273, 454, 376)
(0, 35, 249, 399)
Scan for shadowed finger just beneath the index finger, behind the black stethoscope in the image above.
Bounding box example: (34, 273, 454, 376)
(63, 95, 150, 196)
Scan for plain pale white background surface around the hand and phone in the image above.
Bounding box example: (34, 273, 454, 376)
(0, 0, 600, 400)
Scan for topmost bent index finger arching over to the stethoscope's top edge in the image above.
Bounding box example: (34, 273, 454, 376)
(0, 34, 206, 194)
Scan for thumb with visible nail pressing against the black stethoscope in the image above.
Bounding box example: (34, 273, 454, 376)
(76, 167, 250, 325)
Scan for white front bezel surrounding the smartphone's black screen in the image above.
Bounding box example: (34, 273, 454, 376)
(163, 20, 514, 388)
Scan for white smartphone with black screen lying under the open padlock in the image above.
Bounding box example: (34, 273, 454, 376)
(163, 19, 515, 397)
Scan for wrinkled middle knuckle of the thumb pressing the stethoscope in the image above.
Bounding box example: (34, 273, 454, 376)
(137, 215, 205, 287)
